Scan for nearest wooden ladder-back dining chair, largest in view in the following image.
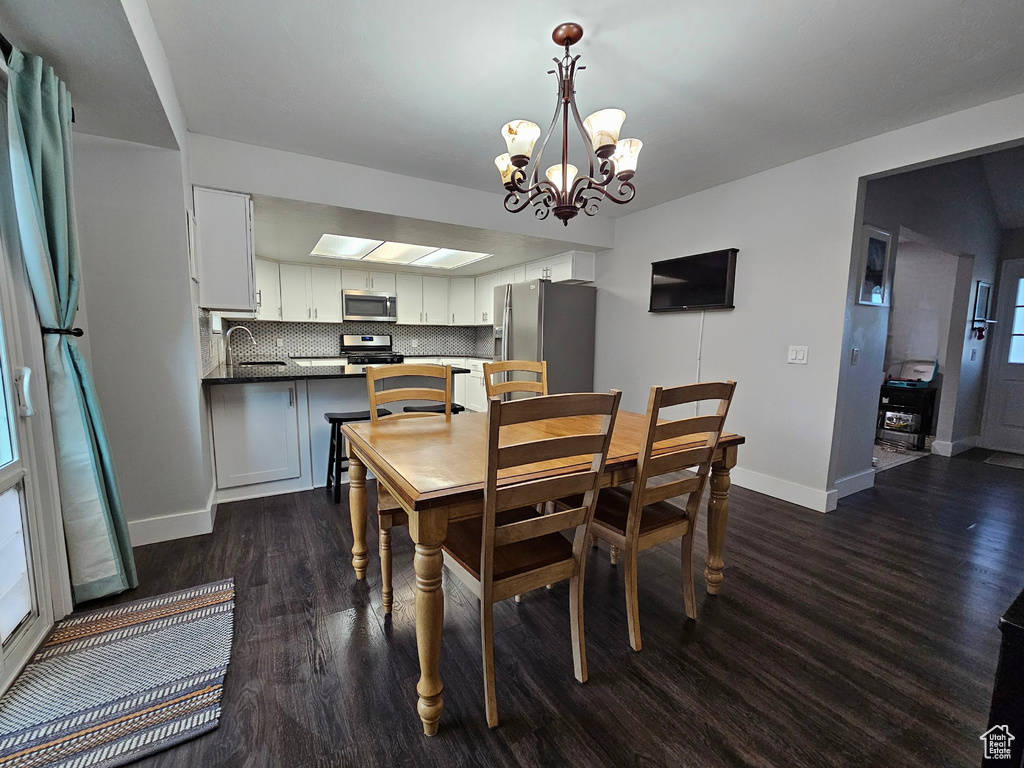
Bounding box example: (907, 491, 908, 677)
(443, 390, 622, 728)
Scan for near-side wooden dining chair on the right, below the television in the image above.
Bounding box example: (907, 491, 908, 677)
(591, 381, 736, 650)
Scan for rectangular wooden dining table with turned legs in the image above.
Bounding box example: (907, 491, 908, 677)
(342, 411, 744, 735)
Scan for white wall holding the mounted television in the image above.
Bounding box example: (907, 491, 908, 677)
(596, 91, 1024, 511)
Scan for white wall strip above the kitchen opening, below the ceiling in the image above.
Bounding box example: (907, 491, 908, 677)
(188, 133, 614, 250)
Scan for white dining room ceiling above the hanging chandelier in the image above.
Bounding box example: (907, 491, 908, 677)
(148, 0, 1024, 214)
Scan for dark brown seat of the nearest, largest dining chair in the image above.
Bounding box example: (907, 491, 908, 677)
(444, 507, 572, 582)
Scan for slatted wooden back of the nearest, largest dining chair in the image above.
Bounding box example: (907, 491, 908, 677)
(480, 390, 622, 590)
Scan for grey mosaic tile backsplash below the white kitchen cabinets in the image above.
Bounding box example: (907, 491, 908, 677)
(220, 319, 494, 371)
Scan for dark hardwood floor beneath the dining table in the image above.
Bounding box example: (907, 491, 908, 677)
(90, 452, 1024, 768)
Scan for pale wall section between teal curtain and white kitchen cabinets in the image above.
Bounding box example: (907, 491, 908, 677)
(75, 134, 213, 543)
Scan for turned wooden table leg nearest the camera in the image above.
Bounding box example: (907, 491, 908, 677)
(409, 510, 447, 736)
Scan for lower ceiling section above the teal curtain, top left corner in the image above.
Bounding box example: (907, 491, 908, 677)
(0, 0, 178, 148)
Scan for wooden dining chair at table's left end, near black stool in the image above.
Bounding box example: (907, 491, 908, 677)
(367, 364, 452, 614)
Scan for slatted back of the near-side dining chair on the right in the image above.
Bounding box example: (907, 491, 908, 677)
(626, 381, 736, 535)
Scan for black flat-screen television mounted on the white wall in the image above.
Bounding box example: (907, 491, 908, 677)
(650, 248, 739, 312)
